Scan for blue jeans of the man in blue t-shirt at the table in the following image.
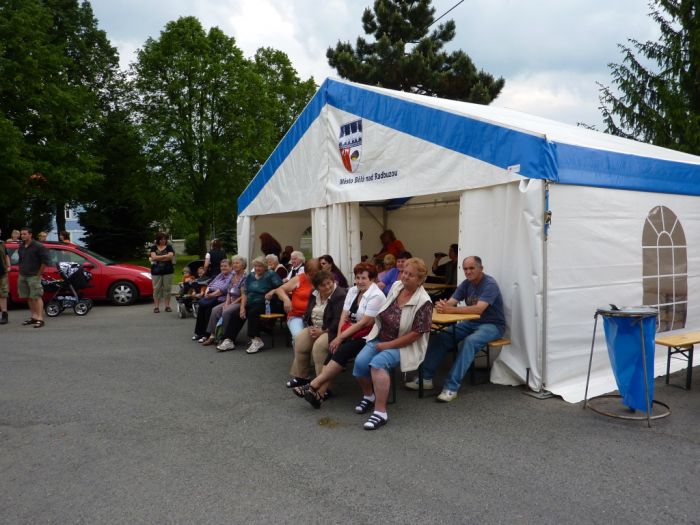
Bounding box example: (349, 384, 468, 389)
(423, 321, 504, 392)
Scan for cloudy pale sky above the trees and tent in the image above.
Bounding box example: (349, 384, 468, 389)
(91, 0, 658, 128)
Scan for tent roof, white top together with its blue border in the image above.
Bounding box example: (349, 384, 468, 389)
(238, 79, 700, 213)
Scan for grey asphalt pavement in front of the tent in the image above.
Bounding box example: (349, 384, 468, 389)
(0, 304, 700, 524)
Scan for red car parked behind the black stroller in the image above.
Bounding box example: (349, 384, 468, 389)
(5, 241, 153, 306)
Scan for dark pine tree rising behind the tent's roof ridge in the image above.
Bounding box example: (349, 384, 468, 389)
(326, 0, 505, 104)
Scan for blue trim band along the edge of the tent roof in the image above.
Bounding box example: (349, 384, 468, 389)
(238, 79, 700, 213)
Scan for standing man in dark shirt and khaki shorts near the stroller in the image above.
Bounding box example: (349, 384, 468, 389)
(17, 228, 51, 328)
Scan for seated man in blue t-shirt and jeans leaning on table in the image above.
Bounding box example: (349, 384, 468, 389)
(406, 255, 506, 403)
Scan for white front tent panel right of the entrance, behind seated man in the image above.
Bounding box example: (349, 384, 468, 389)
(459, 180, 545, 390)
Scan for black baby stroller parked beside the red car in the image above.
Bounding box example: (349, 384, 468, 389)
(41, 262, 92, 317)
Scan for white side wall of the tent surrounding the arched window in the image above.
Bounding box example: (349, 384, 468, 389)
(546, 185, 700, 402)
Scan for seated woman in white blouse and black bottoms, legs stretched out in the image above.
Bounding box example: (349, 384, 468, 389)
(294, 262, 386, 408)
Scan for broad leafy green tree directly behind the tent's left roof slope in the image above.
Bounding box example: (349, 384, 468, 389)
(132, 17, 310, 256)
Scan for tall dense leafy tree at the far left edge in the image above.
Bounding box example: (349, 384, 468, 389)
(0, 0, 118, 229)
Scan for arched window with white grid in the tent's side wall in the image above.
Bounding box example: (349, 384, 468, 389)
(642, 206, 688, 332)
